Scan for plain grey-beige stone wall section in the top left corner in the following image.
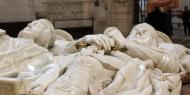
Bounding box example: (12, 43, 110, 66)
(0, 0, 36, 23)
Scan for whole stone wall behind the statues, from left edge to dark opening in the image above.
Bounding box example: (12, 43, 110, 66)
(0, 0, 134, 36)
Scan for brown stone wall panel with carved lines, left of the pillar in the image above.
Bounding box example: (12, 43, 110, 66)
(46, 0, 93, 28)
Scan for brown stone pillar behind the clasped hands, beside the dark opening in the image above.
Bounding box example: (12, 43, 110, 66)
(95, 0, 134, 36)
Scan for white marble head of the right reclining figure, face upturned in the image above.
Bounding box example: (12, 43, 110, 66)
(127, 23, 158, 46)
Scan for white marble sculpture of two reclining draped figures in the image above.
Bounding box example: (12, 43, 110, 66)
(0, 19, 190, 95)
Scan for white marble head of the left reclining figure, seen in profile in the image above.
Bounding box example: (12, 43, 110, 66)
(19, 19, 55, 48)
